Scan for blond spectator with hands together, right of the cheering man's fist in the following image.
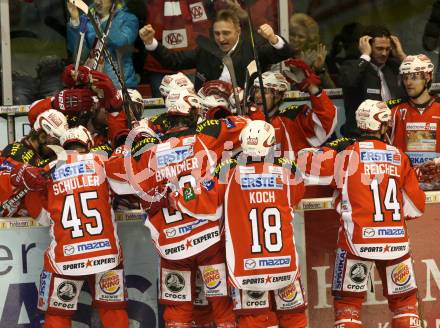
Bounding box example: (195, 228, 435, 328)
(289, 13, 335, 89)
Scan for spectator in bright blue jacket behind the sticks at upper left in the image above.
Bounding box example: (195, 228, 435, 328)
(67, 0, 139, 88)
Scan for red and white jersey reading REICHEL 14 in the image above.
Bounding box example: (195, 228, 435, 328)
(299, 138, 425, 260)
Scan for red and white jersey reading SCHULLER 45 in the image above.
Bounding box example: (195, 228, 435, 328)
(44, 152, 122, 276)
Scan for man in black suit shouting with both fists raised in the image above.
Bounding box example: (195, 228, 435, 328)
(139, 10, 291, 90)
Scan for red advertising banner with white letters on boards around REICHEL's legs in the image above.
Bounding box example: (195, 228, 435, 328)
(304, 204, 440, 328)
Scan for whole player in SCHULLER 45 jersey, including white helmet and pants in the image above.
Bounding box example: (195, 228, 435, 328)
(32, 126, 128, 328)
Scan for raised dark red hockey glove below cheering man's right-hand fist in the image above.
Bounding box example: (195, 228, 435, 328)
(283, 58, 321, 92)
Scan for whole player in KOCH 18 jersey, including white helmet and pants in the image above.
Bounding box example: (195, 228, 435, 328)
(174, 120, 307, 328)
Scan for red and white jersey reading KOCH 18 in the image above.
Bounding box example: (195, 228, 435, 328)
(174, 158, 304, 290)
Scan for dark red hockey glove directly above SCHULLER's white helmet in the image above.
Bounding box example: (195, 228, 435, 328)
(52, 88, 96, 114)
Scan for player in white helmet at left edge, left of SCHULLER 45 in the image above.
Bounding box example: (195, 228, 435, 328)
(0, 109, 67, 217)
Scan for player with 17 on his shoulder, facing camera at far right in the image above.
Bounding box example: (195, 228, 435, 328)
(389, 54, 440, 189)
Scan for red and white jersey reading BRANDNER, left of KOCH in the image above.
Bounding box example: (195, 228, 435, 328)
(106, 117, 247, 260)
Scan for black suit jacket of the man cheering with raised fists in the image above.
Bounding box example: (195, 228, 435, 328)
(151, 37, 292, 90)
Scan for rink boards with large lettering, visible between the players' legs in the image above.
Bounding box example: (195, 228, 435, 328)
(0, 191, 440, 328)
